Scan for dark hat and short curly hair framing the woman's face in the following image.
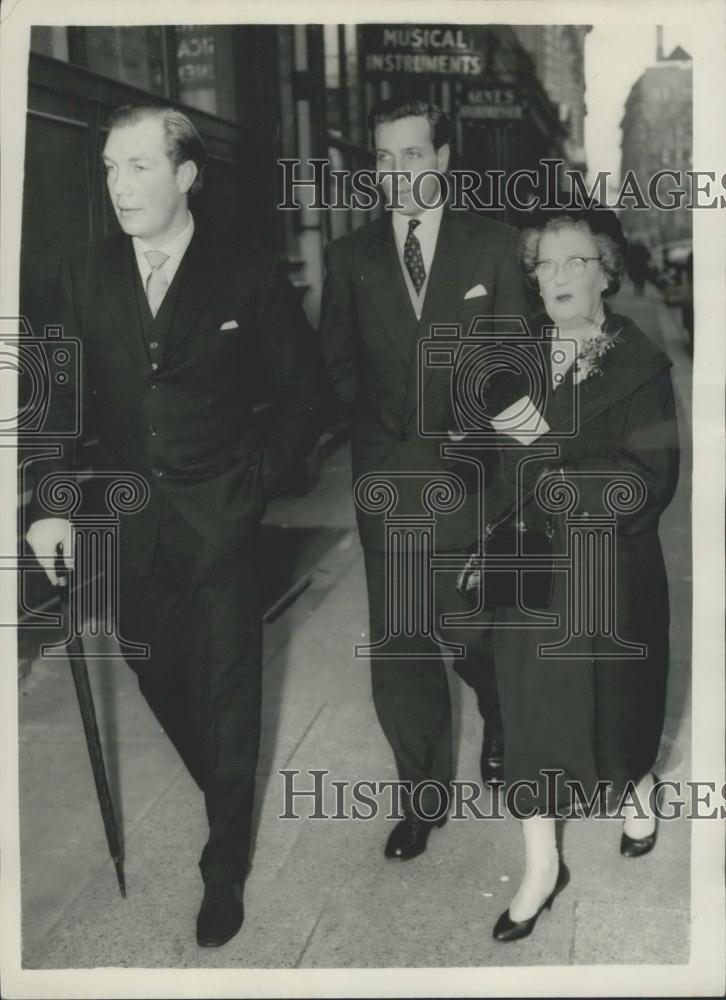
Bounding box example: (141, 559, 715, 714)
(519, 208, 627, 295)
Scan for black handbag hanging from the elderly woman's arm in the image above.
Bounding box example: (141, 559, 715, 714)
(456, 490, 554, 611)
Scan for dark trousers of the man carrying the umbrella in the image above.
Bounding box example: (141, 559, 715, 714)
(119, 502, 262, 883)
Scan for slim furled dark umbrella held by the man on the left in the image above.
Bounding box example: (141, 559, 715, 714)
(61, 577, 126, 899)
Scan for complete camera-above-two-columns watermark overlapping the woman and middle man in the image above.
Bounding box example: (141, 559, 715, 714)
(355, 308, 647, 660)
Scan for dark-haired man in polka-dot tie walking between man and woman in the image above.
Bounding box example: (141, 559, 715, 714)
(321, 99, 527, 860)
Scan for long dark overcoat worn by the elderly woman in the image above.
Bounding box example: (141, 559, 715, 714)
(496, 313, 679, 807)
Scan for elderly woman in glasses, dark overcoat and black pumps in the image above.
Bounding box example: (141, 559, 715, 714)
(480, 209, 678, 941)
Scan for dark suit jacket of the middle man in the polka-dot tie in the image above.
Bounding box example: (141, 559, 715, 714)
(320, 210, 528, 551)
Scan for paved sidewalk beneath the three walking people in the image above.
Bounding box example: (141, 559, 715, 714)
(20, 289, 691, 969)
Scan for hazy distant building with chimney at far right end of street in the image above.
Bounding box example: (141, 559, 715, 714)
(620, 30, 693, 248)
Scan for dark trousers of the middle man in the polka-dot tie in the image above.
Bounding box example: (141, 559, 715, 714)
(365, 549, 502, 811)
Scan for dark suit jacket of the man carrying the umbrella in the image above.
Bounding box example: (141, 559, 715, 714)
(34, 228, 319, 573)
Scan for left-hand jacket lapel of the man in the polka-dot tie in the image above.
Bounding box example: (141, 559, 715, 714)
(360, 213, 417, 364)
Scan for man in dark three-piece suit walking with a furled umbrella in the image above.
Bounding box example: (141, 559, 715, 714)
(27, 106, 318, 946)
